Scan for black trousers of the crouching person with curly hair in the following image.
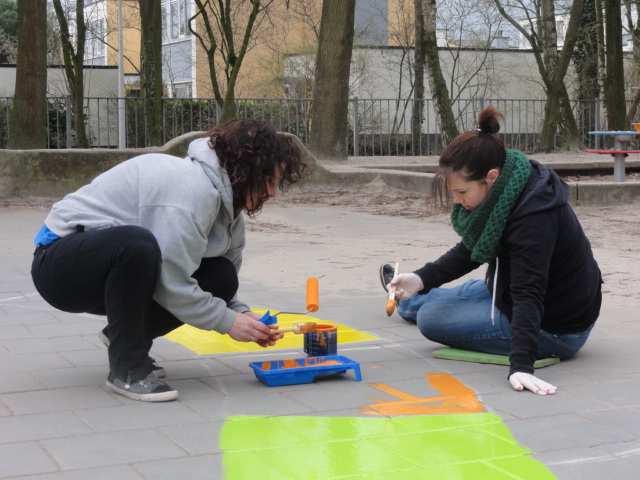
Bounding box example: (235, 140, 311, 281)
(31, 226, 238, 380)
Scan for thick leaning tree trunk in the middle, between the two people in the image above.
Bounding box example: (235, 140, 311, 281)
(310, 0, 355, 160)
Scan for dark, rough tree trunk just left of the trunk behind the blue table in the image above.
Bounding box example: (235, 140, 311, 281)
(573, 0, 600, 142)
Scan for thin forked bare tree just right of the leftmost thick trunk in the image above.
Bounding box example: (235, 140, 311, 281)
(53, 0, 89, 147)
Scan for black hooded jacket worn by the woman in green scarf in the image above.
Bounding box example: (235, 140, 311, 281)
(415, 160, 602, 373)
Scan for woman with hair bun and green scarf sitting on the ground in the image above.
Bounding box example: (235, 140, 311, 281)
(382, 107, 602, 395)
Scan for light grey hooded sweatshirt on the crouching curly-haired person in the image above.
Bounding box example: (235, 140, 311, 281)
(45, 138, 249, 333)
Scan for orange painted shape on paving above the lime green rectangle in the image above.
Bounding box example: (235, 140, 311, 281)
(362, 373, 485, 416)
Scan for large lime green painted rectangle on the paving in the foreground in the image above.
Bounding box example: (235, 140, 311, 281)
(220, 413, 555, 480)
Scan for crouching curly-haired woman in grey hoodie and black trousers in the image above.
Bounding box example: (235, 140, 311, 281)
(31, 120, 305, 401)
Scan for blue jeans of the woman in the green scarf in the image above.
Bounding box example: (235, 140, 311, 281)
(398, 280, 592, 359)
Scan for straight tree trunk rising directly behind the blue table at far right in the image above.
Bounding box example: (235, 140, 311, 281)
(604, 0, 627, 130)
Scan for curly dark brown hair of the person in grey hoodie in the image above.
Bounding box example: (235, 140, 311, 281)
(208, 120, 307, 216)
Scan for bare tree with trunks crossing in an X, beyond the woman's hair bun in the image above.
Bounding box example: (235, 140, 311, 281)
(495, 0, 584, 151)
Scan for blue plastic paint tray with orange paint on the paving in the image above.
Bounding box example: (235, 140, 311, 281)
(249, 355, 362, 387)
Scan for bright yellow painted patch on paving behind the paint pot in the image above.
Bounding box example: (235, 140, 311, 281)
(165, 308, 378, 355)
